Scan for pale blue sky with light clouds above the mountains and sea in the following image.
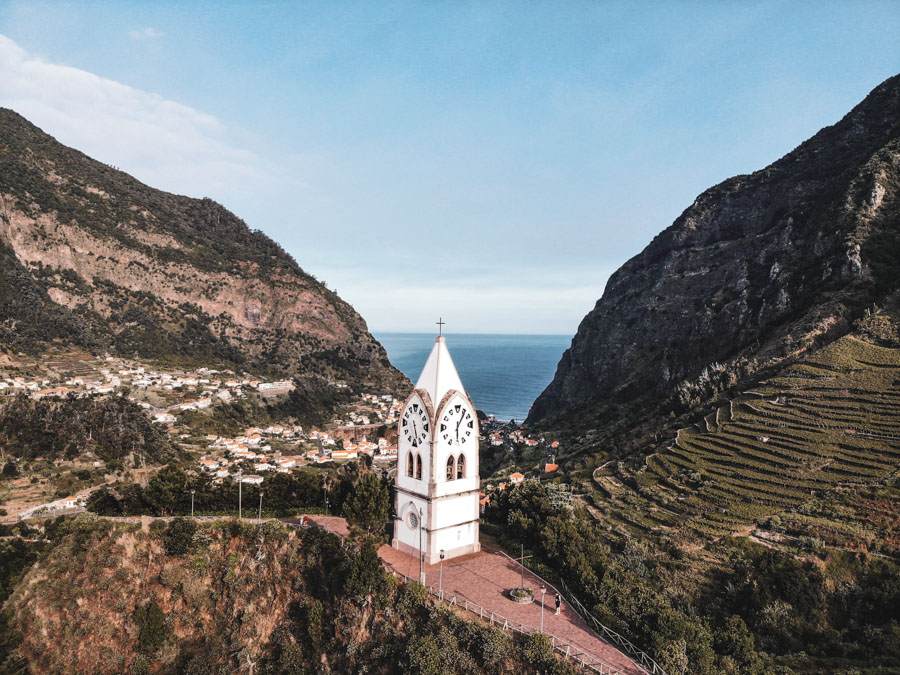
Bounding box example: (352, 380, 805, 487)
(0, 0, 900, 333)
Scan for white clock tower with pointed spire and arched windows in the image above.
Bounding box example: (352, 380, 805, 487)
(392, 337, 481, 565)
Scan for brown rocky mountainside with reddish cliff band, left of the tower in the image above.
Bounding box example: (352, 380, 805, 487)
(0, 109, 405, 388)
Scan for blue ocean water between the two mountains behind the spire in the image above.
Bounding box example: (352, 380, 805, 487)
(373, 333, 572, 422)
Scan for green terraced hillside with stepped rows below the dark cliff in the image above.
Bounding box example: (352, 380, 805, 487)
(595, 336, 900, 552)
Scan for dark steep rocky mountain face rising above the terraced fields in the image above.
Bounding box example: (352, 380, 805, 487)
(529, 76, 900, 422)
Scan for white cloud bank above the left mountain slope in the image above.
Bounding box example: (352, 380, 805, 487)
(0, 35, 269, 197)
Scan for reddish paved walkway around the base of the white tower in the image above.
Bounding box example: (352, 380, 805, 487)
(309, 516, 644, 675)
